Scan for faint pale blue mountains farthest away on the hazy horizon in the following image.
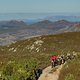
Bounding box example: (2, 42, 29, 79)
(23, 15, 80, 24)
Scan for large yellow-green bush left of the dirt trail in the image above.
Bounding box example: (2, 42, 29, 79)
(2, 58, 37, 80)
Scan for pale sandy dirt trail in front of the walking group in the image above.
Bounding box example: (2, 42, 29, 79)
(38, 65, 63, 80)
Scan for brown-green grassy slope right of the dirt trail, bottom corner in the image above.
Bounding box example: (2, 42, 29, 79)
(59, 56, 80, 80)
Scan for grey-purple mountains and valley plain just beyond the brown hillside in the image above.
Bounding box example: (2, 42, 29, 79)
(0, 20, 80, 45)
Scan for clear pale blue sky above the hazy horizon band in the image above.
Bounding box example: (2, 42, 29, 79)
(0, 0, 80, 13)
